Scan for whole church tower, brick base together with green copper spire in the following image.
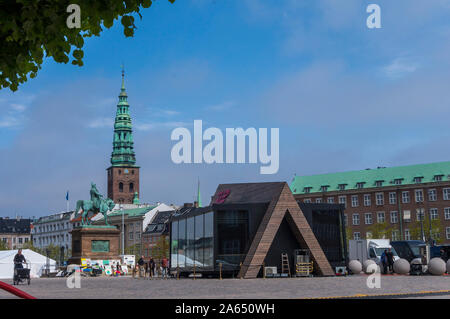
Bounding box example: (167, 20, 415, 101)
(107, 69, 140, 204)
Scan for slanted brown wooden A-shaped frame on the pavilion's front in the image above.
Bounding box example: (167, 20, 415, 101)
(239, 183, 335, 278)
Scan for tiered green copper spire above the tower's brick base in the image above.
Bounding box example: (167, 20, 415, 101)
(111, 66, 136, 166)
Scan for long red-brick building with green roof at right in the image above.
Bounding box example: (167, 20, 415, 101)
(290, 162, 450, 243)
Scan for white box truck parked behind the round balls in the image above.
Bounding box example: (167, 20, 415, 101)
(348, 239, 399, 265)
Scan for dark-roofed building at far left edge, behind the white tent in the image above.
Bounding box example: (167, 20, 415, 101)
(0, 217, 31, 249)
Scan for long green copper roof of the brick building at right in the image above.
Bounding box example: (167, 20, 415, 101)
(290, 162, 450, 194)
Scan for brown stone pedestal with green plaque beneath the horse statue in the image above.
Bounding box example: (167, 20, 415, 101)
(69, 225, 120, 265)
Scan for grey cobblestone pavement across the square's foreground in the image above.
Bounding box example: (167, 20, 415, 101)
(0, 275, 450, 299)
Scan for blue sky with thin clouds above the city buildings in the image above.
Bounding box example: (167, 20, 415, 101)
(0, 0, 450, 216)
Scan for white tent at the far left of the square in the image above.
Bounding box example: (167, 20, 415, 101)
(0, 249, 56, 279)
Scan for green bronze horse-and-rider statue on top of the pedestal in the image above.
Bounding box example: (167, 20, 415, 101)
(75, 183, 115, 226)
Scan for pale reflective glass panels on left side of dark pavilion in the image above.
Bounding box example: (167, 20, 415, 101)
(171, 212, 214, 268)
